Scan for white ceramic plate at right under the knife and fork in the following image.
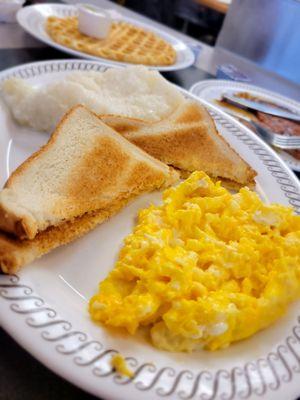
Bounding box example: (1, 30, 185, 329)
(190, 79, 300, 172)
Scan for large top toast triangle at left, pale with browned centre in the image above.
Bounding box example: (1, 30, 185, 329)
(0, 105, 178, 239)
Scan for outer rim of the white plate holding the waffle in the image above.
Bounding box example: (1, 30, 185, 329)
(16, 3, 195, 72)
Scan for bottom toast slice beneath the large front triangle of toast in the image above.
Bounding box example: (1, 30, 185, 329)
(0, 195, 130, 274)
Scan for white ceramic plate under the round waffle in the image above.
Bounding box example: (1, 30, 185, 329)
(17, 3, 195, 71)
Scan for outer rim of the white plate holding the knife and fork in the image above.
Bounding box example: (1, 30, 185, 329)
(189, 79, 300, 172)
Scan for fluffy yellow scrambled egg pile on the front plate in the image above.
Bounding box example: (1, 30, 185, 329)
(90, 172, 300, 351)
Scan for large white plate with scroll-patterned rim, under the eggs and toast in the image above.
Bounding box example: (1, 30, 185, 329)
(0, 60, 300, 400)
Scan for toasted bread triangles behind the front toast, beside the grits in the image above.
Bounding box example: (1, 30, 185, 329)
(99, 100, 256, 187)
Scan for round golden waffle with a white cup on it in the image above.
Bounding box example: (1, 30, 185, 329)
(46, 16, 176, 65)
